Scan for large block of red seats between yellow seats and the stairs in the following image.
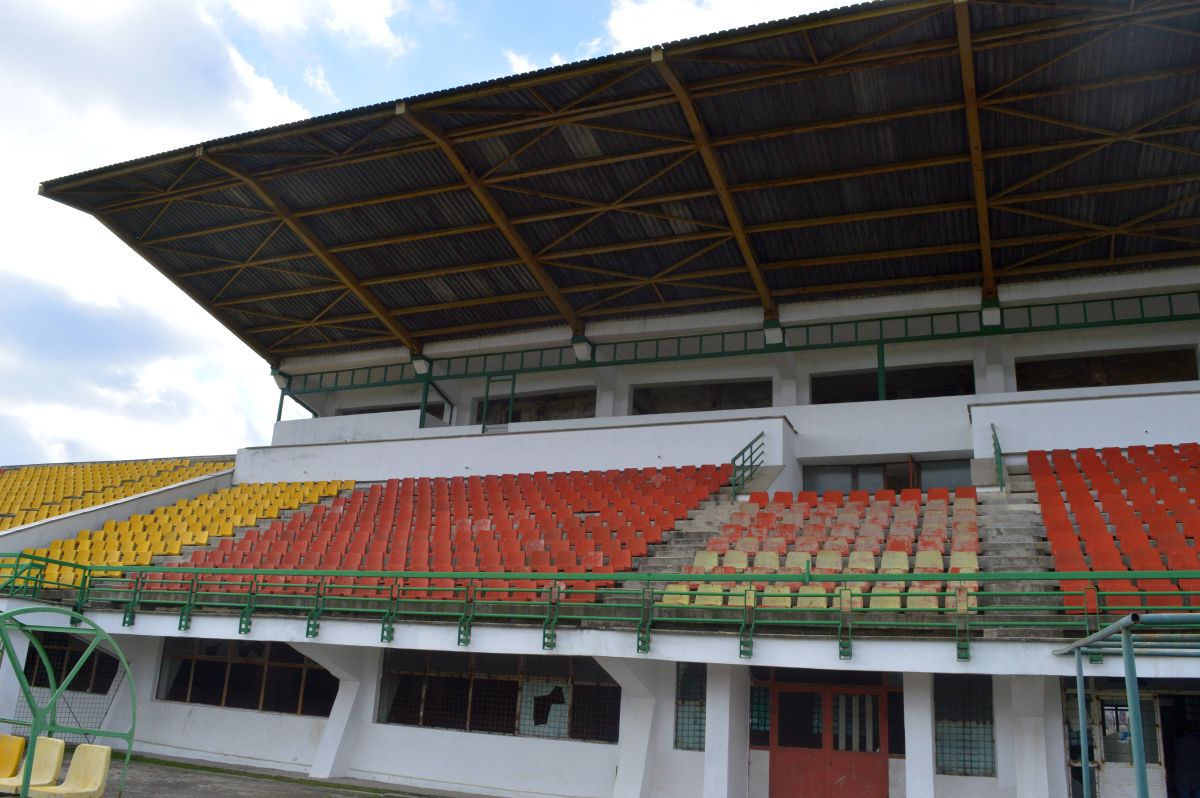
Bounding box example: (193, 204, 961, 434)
(174, 466, 730, 583)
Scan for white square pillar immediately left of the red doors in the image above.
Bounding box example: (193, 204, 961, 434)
(703, 664, 750, 798)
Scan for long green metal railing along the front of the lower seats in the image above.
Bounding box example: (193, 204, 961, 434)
(0, 554, 1200, 660)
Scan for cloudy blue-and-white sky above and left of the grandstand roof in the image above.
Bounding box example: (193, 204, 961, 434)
(0, 0, 846, 464)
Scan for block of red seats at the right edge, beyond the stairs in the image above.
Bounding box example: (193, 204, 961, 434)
(1028, 444, 1200, 612)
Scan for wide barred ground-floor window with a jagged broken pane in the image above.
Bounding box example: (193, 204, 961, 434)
(377, 649, 620, 743)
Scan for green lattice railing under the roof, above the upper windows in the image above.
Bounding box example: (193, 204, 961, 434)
(281, 290, 1200, 396)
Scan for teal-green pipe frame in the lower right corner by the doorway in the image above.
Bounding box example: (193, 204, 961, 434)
(1055, 612, 1200, 798)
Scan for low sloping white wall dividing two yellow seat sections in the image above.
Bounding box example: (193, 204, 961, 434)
(0, 469, 233, 552)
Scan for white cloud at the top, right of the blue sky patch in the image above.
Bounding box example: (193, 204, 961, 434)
(605, 0, 847, 52)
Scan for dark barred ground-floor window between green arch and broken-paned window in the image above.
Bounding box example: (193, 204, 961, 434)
(156, 637, 338, 718)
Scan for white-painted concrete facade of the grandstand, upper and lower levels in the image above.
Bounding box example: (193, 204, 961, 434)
(0, 269, 1200, 798)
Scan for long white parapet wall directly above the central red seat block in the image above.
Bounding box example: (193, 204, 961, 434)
(235, 415, 796, 482)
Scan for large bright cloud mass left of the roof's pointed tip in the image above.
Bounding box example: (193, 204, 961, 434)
(0, 0, 308, 463)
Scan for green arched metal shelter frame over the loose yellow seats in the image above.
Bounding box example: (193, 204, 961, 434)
(0, 606, 138, 798)
